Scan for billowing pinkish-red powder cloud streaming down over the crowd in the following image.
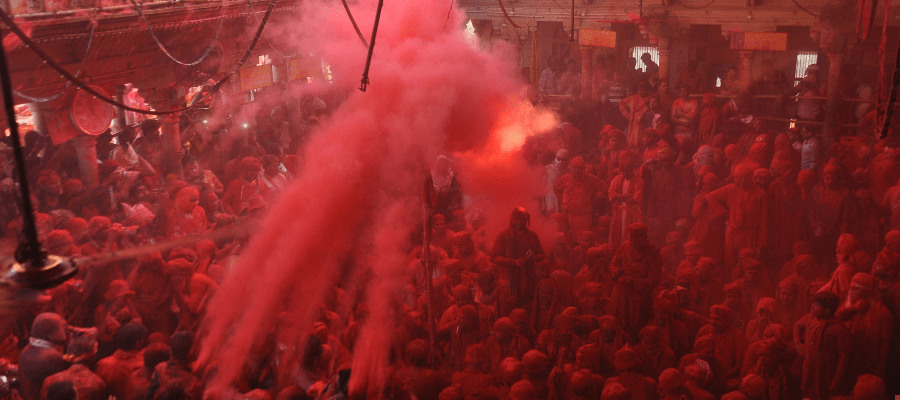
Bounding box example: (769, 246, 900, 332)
(198, 0, 555, 397)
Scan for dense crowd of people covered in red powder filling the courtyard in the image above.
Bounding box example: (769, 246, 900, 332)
(0, 50, 900, 400)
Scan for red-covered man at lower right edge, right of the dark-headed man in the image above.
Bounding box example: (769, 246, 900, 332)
(836, 272, 894, 377)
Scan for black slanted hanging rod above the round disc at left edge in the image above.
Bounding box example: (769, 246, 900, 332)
(0, 29, 47, 268)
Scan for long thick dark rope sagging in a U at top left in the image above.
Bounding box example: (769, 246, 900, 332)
(0, 0, 275, 115)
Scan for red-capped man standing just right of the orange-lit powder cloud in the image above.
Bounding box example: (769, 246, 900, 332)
(553, 157, 609, 235)
